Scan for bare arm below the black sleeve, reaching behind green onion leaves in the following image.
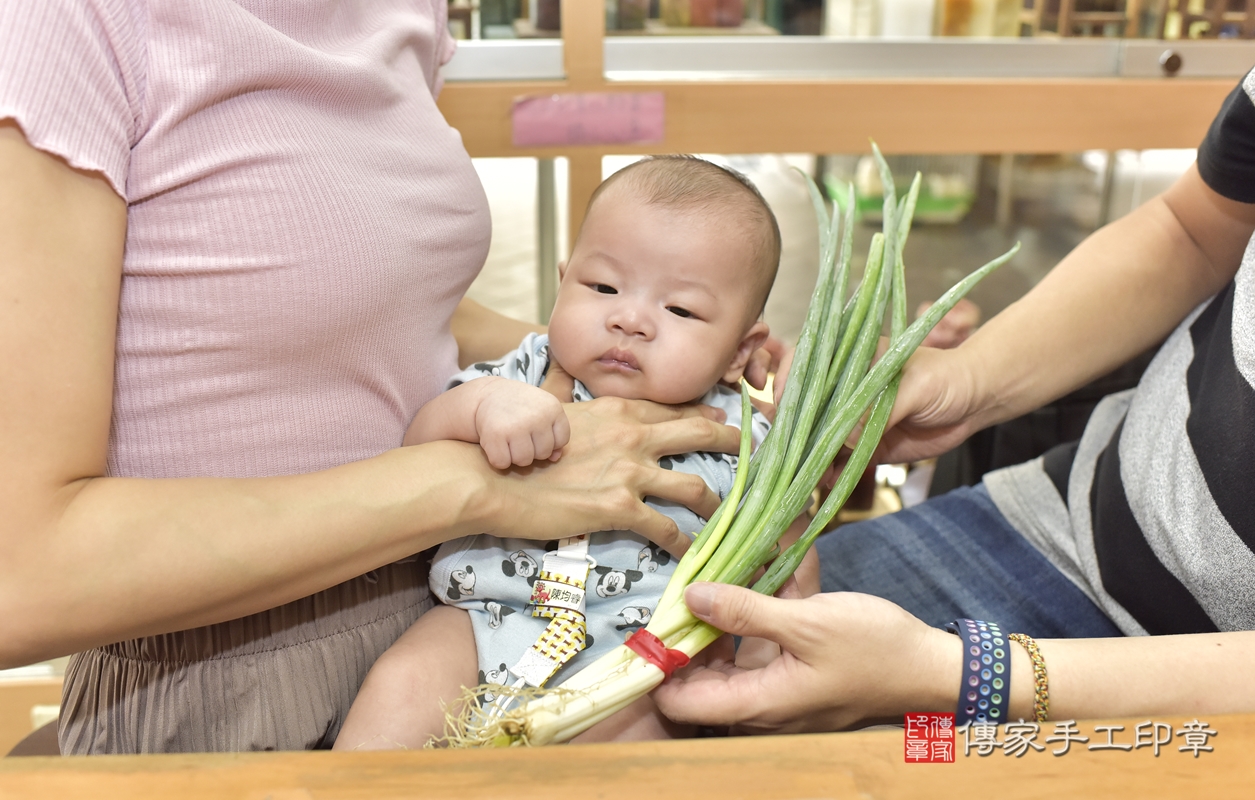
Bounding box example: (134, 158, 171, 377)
(881, 167, 1255, 461)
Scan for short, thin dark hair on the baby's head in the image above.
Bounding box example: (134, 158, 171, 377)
(589, 154, 781, 316)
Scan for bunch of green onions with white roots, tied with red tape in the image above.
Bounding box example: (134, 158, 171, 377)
(448, 144, 1019, 746)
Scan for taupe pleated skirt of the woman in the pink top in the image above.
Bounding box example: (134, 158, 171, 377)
(60, 558, 432, 755)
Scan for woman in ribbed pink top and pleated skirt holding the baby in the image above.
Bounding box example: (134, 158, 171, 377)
(0, 0, 763, 754)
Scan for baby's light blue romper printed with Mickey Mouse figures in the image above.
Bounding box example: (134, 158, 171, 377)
(430, 334, 769, 686)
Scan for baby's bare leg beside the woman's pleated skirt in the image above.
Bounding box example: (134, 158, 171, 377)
(334, 605, 478, 750)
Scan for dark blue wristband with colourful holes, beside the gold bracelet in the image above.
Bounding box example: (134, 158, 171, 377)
(946, 619, 1012, 726)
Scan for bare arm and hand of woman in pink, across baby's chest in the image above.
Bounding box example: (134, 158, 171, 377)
(0, 122, 737, 667)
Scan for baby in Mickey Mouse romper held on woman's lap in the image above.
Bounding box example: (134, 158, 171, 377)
(335, 156, 806, 750)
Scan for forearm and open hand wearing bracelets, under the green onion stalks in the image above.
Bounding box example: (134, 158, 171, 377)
(654, 584, 1255, 733)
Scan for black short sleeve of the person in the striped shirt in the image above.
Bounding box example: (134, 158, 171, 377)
(1199, 73, 1255, 202)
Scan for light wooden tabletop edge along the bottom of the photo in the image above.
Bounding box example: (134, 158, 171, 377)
(0, 715, 1255, 800)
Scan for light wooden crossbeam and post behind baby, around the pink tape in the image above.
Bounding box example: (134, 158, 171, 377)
(439, 0, 1236, 244)
